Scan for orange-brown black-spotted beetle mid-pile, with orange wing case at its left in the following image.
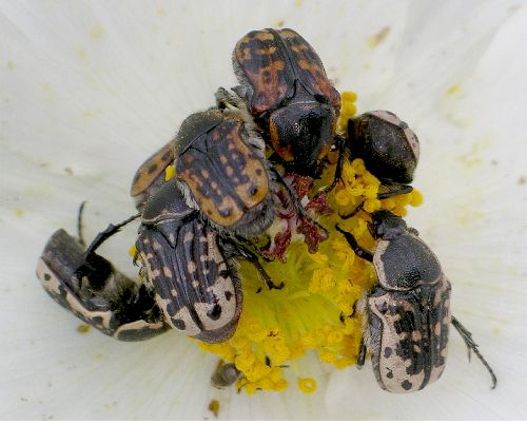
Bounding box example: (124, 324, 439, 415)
(131, 108, 274, 237)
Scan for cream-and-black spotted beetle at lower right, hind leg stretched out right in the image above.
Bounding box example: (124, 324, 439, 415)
(336, 210, 497, 393)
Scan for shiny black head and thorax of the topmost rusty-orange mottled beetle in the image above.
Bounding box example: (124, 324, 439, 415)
(269, 101, 335, 176)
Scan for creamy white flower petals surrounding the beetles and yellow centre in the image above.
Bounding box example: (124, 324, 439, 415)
(0, 1, 527, 419)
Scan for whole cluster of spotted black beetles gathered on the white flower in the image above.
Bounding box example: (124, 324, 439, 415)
(37, 29, 492, 391)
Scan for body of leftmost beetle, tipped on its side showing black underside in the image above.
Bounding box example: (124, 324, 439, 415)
(37, 230, 168, 341)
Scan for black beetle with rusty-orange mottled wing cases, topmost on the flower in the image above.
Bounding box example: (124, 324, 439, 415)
(232, 28, 340, 176)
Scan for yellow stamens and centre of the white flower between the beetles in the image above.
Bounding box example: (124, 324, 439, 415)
(198, 92, 422, 394)
